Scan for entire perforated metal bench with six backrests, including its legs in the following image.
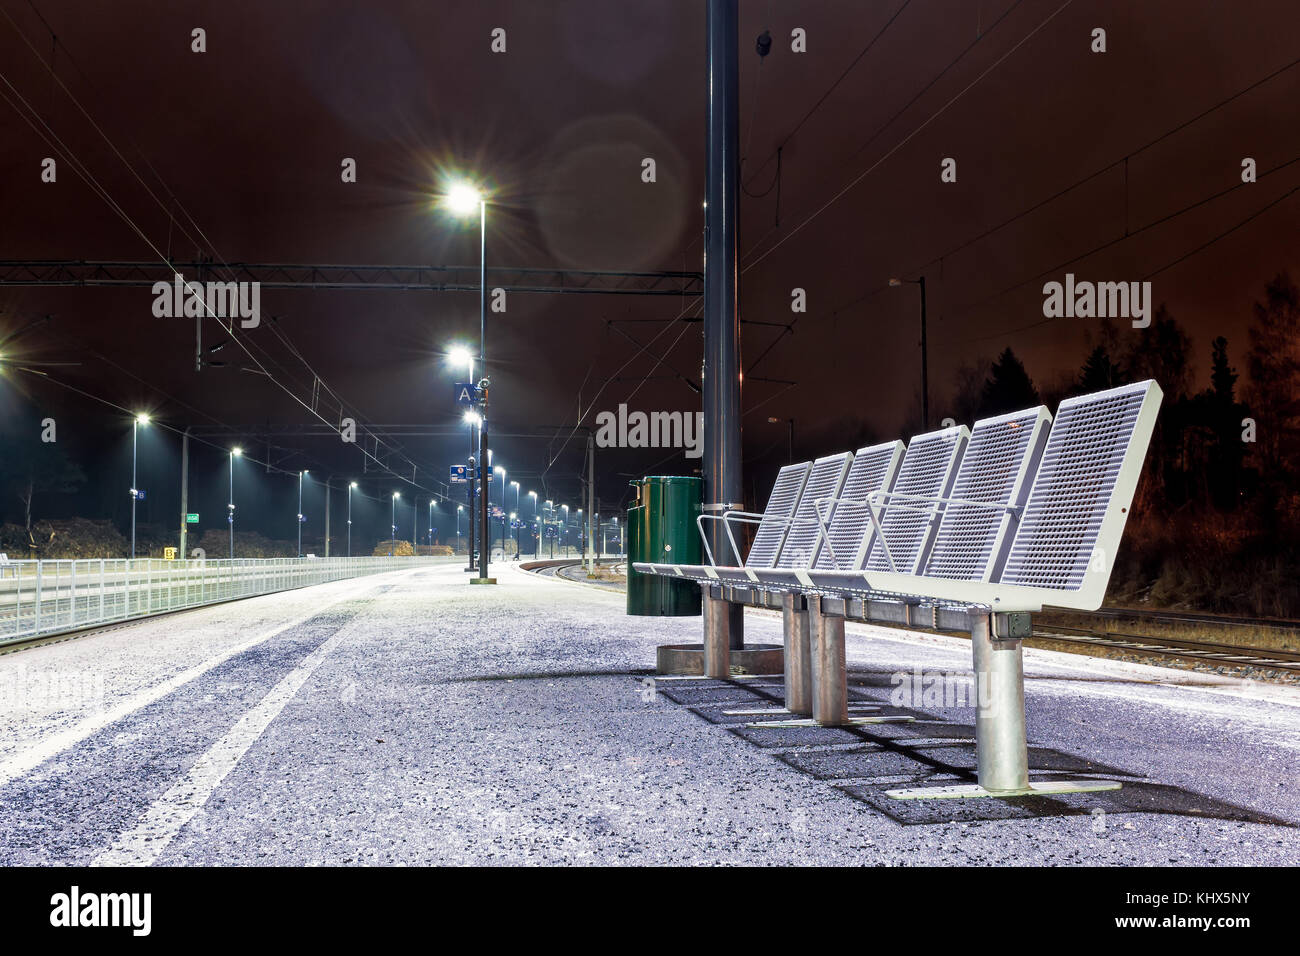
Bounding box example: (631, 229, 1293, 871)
(636, 381, 1162, 799)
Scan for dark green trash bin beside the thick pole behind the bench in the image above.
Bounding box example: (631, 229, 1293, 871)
(628, 475, 703, 618)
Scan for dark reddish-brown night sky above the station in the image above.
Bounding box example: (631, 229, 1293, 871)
(0, 0, 1300, 536)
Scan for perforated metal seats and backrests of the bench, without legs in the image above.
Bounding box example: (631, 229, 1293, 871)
(634, 381, 1162, 611)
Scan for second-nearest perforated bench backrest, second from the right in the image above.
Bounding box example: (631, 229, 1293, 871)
(923, 405, 1052, 581)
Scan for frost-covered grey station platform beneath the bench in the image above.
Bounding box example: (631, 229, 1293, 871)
(0, 564, 1300, 865)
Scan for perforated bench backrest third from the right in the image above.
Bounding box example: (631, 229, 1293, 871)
(866, 425, 971, 574)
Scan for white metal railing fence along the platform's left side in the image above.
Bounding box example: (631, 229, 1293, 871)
(0, 557, 454, 645)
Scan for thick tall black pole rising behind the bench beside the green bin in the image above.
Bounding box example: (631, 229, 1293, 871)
(703, 0, 745, 676)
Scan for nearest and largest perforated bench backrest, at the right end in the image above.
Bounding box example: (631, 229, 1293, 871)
(1000, 381, 1162, 607)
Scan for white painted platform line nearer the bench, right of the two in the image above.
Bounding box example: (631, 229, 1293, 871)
(91, 631, 343, 866)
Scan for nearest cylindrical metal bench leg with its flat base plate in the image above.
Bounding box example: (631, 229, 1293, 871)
(885, 613, 1119, 800)
